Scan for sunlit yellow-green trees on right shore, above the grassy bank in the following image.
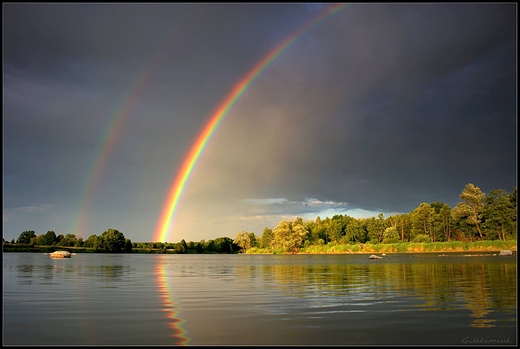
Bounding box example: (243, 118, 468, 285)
(234, 183, 517, 253)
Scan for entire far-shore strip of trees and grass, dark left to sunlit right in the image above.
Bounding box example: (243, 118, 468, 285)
(4, 183, 517, 254)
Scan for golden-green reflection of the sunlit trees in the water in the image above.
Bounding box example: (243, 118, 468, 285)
(237, 256, 516, 328)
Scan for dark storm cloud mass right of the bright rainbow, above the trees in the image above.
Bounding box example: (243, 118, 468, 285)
(187, 5, 516, 211)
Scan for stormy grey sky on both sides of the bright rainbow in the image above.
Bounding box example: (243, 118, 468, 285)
(3, 3, 517, 242)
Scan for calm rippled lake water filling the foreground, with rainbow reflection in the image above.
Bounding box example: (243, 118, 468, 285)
(3, 253, 517, 345)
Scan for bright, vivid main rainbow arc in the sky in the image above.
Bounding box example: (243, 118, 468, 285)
(154, 4, 348, 242)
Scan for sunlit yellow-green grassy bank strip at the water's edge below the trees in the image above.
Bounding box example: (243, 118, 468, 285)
(247, 240, 516, 254)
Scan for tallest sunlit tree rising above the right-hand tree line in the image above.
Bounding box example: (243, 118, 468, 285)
(453, 183, 486, 240)
